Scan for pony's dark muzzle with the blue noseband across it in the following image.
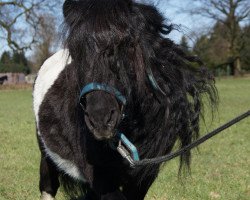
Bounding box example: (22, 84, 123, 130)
(80, 83, 126, 140)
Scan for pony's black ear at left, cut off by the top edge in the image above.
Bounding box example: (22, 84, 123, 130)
(63, 0, 81, 26)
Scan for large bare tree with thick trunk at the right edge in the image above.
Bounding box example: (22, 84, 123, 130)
(188, 0, 250, 75)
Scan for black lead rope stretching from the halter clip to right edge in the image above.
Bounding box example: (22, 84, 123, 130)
(130, 110, 250, 168)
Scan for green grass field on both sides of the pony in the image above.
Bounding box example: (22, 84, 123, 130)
(0, 78, 250, 200)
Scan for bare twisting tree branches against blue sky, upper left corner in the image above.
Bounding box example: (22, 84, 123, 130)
(0, 0, 61, 51)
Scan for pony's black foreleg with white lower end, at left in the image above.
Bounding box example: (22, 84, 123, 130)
(39, 153, 59, 200)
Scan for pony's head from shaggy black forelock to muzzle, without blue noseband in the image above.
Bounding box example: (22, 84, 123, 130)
(63, 0, 146, 139)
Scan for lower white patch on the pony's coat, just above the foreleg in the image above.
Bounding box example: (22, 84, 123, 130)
(41, 139, 86, 182)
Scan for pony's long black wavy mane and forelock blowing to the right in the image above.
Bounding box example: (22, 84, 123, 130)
(64, 0, 216, 172)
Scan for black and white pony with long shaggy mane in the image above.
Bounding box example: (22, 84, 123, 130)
(33, 0, 216, 200)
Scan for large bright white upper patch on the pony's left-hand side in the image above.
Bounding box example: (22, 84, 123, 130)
(33, 49, 71, 135)
